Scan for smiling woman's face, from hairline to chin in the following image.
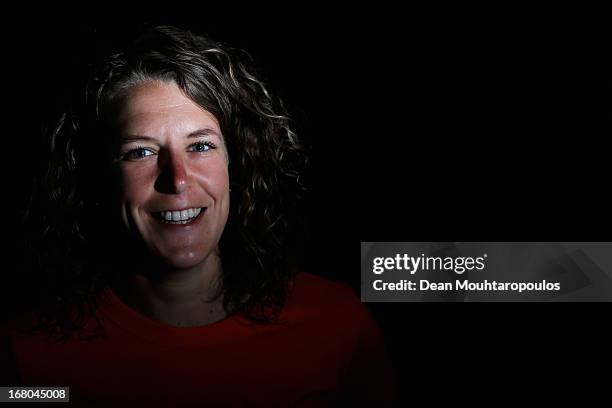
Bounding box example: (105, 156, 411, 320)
(115, 81, 229, 268)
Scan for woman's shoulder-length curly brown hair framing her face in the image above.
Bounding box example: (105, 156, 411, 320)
(27, 26, 306, 338)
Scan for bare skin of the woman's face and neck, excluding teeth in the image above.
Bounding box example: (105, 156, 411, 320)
(109, 81, 229, 326)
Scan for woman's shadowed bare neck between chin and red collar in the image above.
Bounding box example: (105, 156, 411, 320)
(113, 252, 226, 327)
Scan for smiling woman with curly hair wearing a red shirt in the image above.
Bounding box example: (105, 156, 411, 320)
(2, 27, 392, 406)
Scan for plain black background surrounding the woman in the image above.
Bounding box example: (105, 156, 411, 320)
(1, 5, 612, 402)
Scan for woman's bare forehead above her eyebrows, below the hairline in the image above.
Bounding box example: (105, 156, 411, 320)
(115, 80, 219, 131)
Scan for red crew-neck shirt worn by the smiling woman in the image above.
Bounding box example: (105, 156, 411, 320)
(2, 273, 393, 407)
